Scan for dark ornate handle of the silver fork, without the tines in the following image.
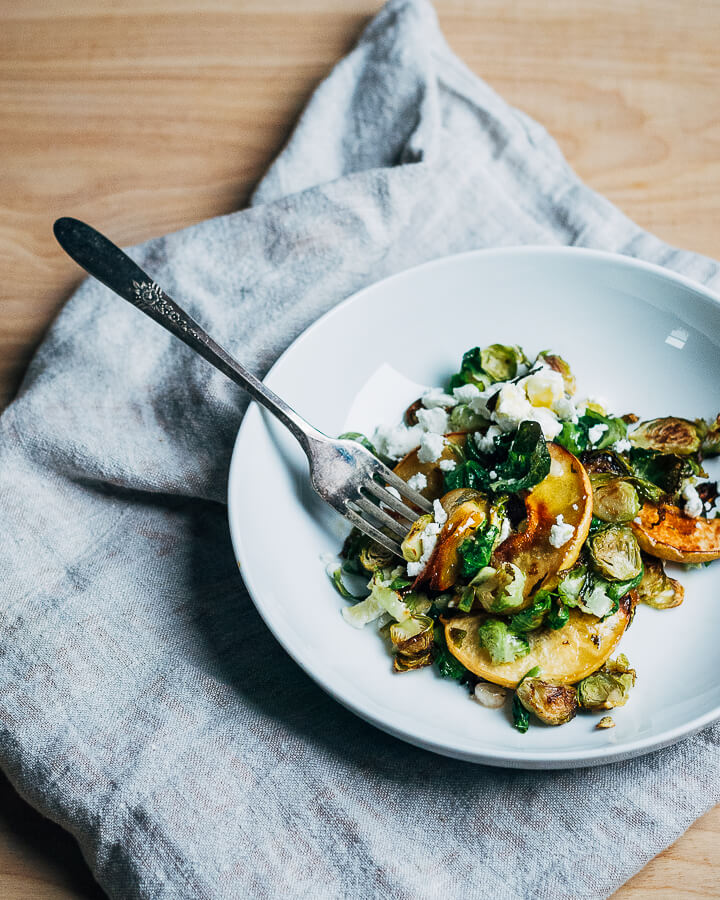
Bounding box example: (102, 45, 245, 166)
(53, 217, 327, 449)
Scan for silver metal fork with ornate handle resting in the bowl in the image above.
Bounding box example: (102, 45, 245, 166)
(54, 218, 432, 556)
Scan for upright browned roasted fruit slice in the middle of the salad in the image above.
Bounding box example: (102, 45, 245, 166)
(492, 444, 592, 597)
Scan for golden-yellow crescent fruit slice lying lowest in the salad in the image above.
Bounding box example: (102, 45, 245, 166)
(445, 592, 635, 687)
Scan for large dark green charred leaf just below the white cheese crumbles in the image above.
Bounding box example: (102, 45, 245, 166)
(445, 422, 550, 494)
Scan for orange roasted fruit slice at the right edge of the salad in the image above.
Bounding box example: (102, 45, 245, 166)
(629, 503, 720, 563)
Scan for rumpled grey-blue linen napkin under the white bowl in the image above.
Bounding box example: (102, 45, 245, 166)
(0, 0, 720, 900)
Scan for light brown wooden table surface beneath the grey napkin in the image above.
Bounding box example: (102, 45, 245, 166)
(0, 0, 720, 900)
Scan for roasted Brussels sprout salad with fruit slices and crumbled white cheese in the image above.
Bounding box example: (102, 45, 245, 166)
(328, 344, 720, 732)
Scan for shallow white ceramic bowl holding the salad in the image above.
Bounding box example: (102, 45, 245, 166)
(229, 248, 720, 768)
